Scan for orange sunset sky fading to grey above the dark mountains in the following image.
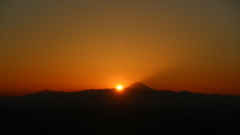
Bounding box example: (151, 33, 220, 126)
(0, 0, 240, 95)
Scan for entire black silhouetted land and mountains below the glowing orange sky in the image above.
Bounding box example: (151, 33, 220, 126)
(0, 82, 240, 135)
